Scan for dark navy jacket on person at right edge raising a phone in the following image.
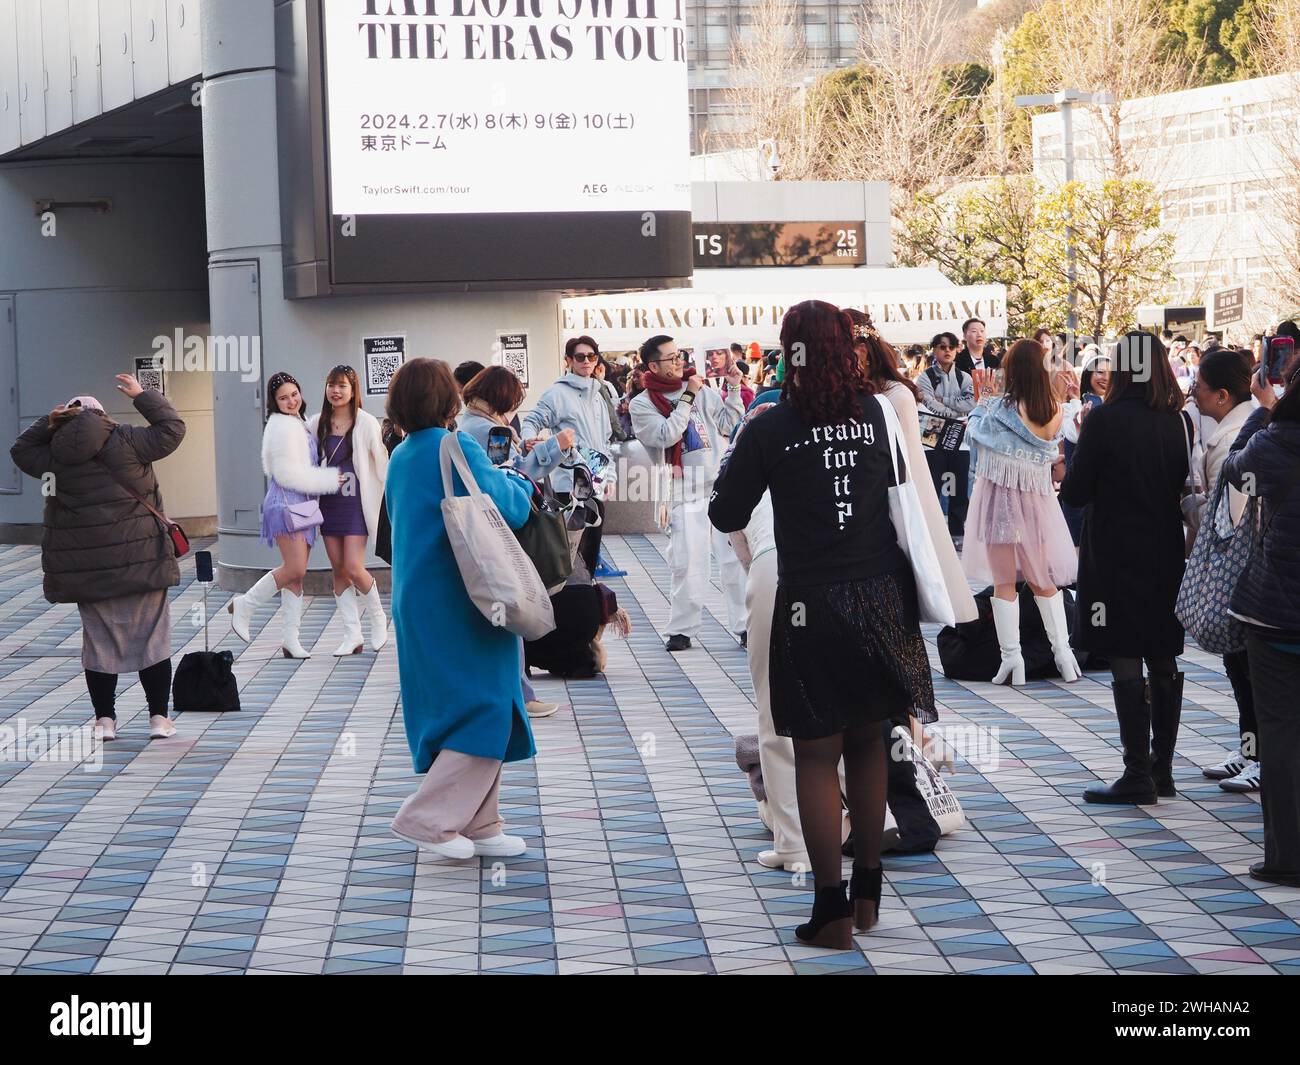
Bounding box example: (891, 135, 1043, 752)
(1223, 410, 1300, 633)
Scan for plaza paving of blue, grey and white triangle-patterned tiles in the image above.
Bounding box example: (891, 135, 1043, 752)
(0, 536, 1300, 975)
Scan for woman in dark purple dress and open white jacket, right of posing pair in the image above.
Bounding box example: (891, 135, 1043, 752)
(307, 365, 389, 657)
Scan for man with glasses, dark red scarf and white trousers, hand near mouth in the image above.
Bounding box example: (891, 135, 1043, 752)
(628, 335, 745, 651)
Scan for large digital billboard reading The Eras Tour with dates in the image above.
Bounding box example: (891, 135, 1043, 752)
(309, 0, 692, 287)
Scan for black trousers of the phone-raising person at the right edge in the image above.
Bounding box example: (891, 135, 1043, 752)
(1245, 632, 1300, 874)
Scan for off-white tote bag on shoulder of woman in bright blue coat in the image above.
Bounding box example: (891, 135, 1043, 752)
(438, 433, 555, 640)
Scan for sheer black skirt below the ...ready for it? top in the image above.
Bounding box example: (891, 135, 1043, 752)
(768, 570, 939, 740)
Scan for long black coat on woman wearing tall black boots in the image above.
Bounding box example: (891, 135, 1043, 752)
(1061, 385, 1187, 658)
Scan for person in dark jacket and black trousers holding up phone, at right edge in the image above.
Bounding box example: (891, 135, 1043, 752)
(1222, 359, 1300, 887)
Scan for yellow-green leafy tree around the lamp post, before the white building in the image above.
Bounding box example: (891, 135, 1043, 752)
(1036, 178, 1174, 337)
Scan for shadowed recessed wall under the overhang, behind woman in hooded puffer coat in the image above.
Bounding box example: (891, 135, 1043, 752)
(0, 160, 216, 534)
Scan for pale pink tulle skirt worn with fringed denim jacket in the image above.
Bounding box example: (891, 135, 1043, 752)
(962, 477, 1079, 588)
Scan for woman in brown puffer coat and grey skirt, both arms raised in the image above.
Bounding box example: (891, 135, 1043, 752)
(9, 373, 185, 740)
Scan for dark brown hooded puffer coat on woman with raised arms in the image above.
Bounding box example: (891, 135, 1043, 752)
(9, 389, 185, 603)
